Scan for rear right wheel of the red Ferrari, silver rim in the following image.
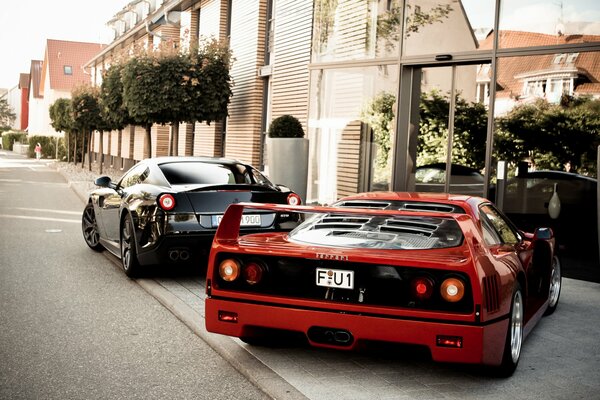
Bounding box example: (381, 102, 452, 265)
(498, 284, 525, 377)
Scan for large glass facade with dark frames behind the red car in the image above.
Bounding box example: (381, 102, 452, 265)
(307, 0, 600, 278)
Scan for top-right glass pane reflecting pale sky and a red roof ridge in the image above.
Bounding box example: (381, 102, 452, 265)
(499, 0, 600, 48)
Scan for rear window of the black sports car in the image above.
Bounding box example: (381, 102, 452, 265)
(159, 162, 253, 185)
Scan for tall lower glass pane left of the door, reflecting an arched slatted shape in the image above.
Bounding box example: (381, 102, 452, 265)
(307, 65, 398, 204)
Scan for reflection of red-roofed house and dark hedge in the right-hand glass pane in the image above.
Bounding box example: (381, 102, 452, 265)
(494, 52, 600, 177)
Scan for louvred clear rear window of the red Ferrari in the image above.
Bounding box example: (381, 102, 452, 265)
(289, 214, 463, 250)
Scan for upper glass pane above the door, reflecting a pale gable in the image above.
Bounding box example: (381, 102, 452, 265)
(404, 0, 494, 56)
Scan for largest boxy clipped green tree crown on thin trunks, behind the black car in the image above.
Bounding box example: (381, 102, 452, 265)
(121, 40, 232, 157)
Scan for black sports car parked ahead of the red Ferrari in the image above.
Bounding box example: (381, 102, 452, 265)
(82, 157, 301, 277)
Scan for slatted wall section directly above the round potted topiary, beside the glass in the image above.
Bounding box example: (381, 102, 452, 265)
(271, 0, 313, 125)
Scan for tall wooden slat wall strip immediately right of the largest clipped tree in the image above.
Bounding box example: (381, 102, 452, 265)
(225, 0, 266, 165)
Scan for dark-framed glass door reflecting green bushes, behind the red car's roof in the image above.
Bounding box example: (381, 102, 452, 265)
(399, 64, 490, 196)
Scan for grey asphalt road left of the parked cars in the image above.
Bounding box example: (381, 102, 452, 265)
(0, 151, 268, 399)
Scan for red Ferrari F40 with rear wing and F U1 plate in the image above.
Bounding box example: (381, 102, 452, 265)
(205, 192, 561, 376)
